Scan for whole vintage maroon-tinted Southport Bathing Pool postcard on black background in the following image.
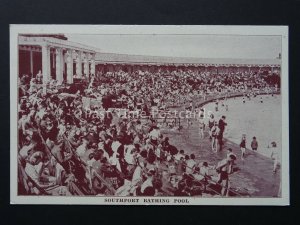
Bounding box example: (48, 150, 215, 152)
(10, 25, 289, 206)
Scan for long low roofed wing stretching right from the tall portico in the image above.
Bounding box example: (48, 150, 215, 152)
(95, 52, 281, 74)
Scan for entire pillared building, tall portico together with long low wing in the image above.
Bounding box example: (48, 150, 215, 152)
(18, 34, 281, 92)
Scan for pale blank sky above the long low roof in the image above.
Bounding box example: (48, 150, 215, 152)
(66, 34, 281, 59)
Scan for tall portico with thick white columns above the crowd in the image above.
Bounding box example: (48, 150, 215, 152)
(18, 34, 96, 90)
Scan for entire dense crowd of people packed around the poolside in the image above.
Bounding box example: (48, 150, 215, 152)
(18, 66, 278, 196)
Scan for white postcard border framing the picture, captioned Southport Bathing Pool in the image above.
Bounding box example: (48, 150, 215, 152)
(10, 25, 290, 206)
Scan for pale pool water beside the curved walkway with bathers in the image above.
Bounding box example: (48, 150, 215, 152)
(204, 95, 282, 157)
